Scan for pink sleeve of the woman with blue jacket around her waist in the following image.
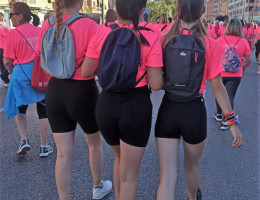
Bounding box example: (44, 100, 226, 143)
(4, 29, 15, 60)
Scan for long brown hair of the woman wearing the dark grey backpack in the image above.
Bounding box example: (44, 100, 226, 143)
(163, 0, 207, 48)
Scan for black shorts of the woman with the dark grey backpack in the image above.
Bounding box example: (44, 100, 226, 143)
(155, 96, 207, 144)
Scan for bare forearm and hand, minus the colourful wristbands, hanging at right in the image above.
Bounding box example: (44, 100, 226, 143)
(211, 75, 243, 148)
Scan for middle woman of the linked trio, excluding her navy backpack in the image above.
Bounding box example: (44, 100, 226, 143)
(82, 0, 163, 200)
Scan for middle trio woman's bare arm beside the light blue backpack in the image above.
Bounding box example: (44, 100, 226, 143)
(81, 57, 98, 78)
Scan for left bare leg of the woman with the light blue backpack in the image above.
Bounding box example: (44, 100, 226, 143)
(53, 131, 75, 200)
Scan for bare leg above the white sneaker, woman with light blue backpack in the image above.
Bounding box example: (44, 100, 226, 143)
(85, 132, 103, 185)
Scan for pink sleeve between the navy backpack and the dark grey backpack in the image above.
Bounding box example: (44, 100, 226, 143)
(146, 36, 163, 67)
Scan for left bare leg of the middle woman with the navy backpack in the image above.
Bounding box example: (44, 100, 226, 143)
(110, 145, 120, 200)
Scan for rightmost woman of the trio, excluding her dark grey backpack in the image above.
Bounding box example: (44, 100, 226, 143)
(155, 0, 243, 200)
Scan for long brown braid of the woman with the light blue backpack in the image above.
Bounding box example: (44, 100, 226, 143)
(55, 0, 76, 43)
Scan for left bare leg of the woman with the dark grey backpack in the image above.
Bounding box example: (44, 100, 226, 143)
(156, 138, 180, 200)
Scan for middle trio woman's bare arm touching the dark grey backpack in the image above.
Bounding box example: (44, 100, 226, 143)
(147, 67, 164, 91)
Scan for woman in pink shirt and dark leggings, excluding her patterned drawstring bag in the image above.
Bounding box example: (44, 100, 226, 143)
(215, 18, 251, 130)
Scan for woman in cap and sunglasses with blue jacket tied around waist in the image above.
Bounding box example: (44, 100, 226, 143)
(4, 2, 53, 157)
